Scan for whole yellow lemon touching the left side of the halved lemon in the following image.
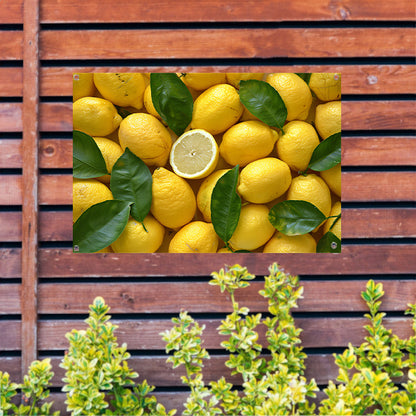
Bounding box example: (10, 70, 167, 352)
(118, 113, 172, 166)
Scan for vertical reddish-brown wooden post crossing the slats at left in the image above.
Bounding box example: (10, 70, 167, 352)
(21, 0, 39, 374)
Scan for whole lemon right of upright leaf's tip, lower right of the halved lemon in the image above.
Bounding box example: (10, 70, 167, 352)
(237, 157, 292, 204)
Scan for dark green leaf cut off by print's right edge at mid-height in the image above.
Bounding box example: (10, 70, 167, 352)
(308, 132, 341, 172)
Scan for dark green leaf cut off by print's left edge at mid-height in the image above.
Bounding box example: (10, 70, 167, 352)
(72, 130, 108, 179)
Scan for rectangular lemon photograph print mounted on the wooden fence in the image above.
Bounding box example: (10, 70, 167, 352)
(73, 72, 341, 253)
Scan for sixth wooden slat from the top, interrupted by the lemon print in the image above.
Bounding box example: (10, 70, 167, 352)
(0, 171, 416, 205)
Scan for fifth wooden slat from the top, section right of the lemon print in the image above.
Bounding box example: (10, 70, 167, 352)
(341, 137, 416, 166)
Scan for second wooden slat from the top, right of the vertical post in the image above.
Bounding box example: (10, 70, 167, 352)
(40, 28, 415, 60)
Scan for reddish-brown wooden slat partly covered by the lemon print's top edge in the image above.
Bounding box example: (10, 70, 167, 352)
(36, 65, 416, 97)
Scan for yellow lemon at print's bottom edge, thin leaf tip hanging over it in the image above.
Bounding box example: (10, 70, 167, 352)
(111, 215, 165, 253)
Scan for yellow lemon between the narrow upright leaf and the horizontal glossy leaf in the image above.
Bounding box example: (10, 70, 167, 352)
(229, 204, 276, 250)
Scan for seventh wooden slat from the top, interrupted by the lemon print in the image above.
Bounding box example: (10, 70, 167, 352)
(0, 208, 416, 242)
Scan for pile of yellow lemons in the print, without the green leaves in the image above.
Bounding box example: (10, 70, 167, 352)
(73, 73, 341, 253)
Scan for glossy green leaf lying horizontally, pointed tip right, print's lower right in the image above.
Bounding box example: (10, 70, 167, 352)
(269, 200, 326, 235)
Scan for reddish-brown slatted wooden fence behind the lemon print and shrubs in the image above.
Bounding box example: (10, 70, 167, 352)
(0, 0, 416, 409)
